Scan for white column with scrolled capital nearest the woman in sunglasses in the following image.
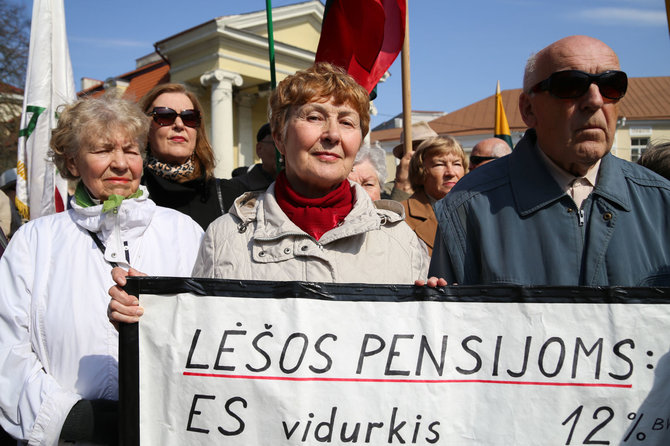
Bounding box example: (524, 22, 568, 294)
(200, 69, 242, 178)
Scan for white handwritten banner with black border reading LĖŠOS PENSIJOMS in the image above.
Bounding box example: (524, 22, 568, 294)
(121, 278, 670, 445)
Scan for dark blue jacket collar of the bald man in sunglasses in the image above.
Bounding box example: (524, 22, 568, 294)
(509, 129, 631, 215)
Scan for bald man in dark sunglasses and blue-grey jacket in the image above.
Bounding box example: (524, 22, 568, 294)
(429, 36, 670, 286)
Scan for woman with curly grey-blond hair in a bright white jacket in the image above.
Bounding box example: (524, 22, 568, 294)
(0, 93, 203, 445)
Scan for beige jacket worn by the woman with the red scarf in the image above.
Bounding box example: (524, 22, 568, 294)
(193, 184, 430, 284)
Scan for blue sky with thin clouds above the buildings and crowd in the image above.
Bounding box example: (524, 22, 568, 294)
(52, 0, 670, 125)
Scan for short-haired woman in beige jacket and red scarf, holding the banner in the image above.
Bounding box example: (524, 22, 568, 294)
(110, 63, 428, 322)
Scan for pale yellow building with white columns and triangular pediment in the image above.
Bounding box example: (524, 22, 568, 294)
(80, 0, 324, 178)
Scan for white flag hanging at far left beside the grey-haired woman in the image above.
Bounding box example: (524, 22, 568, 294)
(16, 0, 77, 218)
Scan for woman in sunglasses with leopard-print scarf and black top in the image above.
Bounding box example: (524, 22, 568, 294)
(140, 84, 242, 229)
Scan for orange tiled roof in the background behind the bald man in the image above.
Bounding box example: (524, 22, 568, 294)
(370, 76, 670, 142)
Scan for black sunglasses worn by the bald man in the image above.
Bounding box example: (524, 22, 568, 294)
(530, 70, 628, 101)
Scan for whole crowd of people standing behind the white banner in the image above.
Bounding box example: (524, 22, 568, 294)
(0, 36, 670, 445)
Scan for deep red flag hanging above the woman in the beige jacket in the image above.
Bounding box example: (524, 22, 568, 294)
(315, 0, 406, 93)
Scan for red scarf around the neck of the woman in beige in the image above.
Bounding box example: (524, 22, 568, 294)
(275, 171, 354, 240)
